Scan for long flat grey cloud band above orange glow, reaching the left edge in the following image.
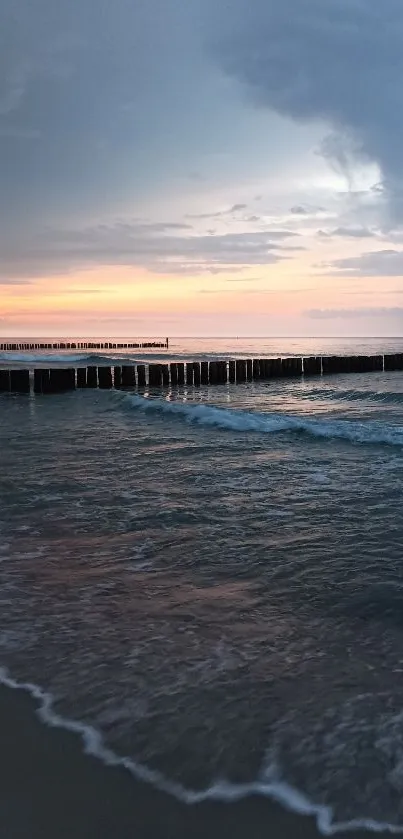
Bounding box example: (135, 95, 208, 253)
(0, 221, 302, 282)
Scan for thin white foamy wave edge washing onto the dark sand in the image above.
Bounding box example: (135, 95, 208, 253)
(0, 667, 403, 836)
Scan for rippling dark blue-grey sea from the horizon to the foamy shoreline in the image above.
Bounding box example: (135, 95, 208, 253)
(0, 338, 403, 837)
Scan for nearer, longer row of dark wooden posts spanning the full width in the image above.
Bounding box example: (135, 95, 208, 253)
(0, 353, 403, 393)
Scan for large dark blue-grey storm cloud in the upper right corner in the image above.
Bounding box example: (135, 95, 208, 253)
(211, 0, 403, 213)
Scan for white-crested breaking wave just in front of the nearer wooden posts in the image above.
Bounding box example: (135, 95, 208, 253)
(123, 394, 403, 446)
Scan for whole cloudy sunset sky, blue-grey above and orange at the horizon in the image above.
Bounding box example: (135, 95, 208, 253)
(0, 0, 403, 337)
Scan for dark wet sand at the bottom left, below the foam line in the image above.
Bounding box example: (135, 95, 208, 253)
(0, 687, 390, 839)
